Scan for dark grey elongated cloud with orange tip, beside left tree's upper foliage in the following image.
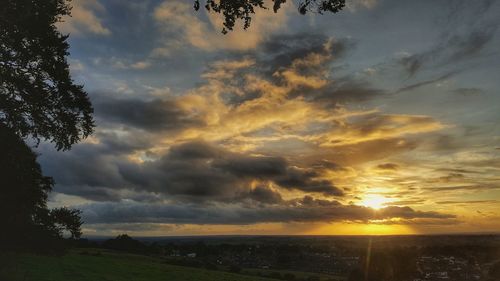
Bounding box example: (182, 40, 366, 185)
(93, 96, 203, 132)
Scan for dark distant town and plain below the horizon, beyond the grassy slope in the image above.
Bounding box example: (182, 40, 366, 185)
(75, 235, 500, 281)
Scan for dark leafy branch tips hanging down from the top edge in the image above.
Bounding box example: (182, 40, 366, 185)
(194, 0, 345, 33)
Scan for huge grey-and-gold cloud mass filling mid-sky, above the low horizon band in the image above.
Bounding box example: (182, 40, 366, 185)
(42, 34, 450, 206)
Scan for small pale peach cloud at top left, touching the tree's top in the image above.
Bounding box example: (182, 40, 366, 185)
(58, 0, 111, 35)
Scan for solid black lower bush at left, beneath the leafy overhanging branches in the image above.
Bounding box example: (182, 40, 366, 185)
(0, 124, 82, 251)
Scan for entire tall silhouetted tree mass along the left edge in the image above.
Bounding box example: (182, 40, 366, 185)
(0, 0, 89, 249)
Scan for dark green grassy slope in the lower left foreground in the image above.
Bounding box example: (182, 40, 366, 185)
(0, 250, 276, 281)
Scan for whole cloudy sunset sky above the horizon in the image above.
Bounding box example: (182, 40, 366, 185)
(36, 0, 500, 236)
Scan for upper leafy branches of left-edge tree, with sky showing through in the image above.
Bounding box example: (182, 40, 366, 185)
(0, 0, 94, 150)
